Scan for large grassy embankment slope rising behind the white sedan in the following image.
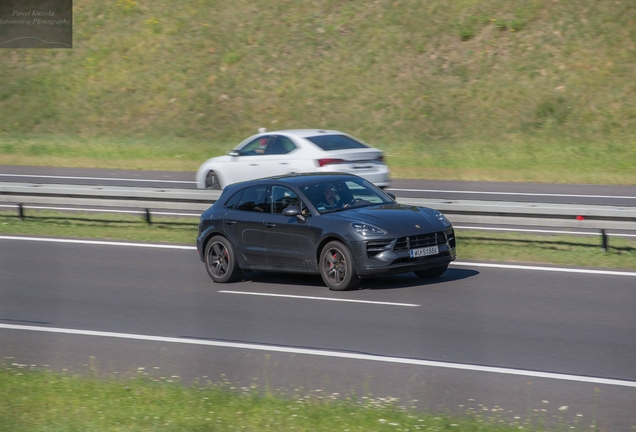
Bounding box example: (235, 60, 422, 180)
(0, 0, 636, 185)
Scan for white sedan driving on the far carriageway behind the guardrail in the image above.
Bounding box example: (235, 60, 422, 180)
(196, 129, 389, 189)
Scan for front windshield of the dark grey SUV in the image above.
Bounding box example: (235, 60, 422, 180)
(301, 178, 393, 213)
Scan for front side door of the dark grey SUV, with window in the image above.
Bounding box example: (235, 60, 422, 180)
(264, 185, 318, 272)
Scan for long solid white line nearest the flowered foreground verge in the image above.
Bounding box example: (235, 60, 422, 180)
(0, 324, 636, 388)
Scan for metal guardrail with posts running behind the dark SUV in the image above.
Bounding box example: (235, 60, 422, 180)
(0, 182, 636, 249)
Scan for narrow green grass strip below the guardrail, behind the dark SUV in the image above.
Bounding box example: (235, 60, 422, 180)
(0, 210, 636, 269)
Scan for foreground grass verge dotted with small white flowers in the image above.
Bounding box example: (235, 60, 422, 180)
(0, 358, 597, 432)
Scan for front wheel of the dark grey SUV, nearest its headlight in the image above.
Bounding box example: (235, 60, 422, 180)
(319, 241, 360, 291)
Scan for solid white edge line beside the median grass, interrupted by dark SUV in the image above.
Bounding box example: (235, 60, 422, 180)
(0, 235, 636, 276)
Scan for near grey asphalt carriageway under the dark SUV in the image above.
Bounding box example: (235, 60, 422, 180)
(0, 237, 636, 431)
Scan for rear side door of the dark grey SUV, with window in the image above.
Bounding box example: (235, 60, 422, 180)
(223, 185, 268, 268)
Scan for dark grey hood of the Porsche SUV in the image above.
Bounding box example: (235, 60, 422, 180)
(323, 203, 447, 237)
